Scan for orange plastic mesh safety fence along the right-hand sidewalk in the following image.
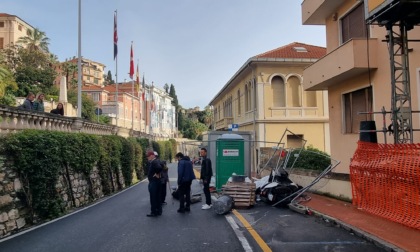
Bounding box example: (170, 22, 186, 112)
(350, 141, 420, 229)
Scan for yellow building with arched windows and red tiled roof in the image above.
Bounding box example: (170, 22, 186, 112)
(209, 42, 330, 175)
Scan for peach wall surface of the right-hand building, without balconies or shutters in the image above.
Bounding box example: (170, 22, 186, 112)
(315, 0, 420, 173)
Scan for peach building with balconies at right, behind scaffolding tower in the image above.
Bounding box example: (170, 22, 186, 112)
(302, 0, 420, 175)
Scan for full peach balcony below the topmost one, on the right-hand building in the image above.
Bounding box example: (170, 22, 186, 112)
(303, 39, 378, 91)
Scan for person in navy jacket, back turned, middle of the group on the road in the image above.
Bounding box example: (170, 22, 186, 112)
(175, 152, 195, 213)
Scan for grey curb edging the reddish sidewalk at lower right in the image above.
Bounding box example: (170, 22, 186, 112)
(289, 204, 405, 252)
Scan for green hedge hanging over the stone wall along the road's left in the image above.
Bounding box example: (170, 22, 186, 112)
(2, 130, 144, 221)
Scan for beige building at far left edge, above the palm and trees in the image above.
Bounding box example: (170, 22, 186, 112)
(0, 13, 34, 49)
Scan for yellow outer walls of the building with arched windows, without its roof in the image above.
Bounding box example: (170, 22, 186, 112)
(211, 57, 330, 175)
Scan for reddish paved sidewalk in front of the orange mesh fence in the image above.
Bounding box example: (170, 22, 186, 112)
(300, 193, 420, 251)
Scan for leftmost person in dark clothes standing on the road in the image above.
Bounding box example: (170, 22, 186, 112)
(146, 151, 162, 217)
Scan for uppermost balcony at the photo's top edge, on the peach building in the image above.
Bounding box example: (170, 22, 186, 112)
(302, 0, 345, 25)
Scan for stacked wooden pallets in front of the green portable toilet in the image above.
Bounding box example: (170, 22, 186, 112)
(222, 182, 256, 207)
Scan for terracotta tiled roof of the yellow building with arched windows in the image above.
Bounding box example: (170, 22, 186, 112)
(254, 42, 327, 59)
